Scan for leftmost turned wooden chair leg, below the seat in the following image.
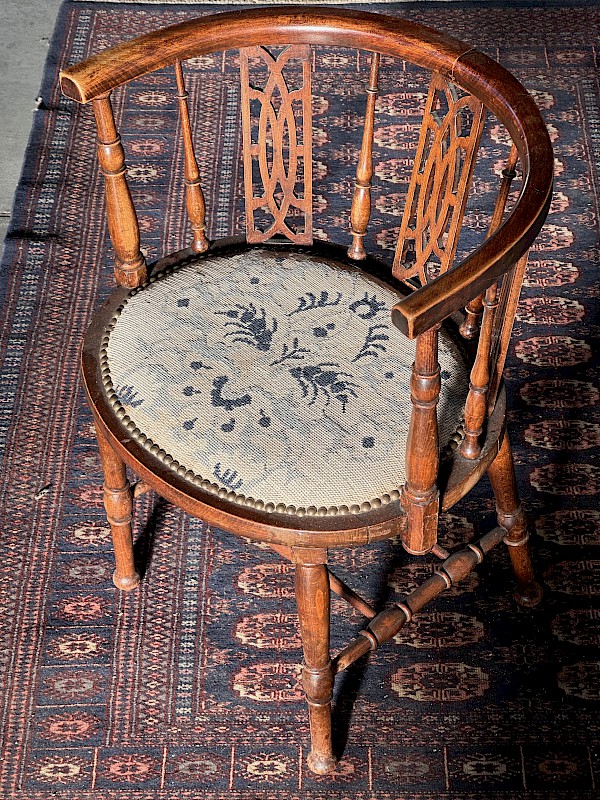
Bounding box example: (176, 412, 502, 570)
(96, 425, 140, 591)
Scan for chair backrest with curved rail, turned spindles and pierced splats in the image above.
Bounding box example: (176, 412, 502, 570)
(61, 8, 552, 552)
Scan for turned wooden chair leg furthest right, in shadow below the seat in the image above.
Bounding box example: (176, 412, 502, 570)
(488, 433, 542, 607)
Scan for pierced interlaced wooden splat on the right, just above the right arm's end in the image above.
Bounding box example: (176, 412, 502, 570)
(393, 72, 485, 283)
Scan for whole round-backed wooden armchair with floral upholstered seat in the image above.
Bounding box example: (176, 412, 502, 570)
(61, 7, 553, 773)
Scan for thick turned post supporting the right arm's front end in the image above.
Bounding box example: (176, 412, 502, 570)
(402, 325, 441, 555)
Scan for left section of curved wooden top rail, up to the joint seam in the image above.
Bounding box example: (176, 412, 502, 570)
(60, 6, 482, 103)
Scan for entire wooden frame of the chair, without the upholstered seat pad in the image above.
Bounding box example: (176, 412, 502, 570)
(61, 6, 553, 773)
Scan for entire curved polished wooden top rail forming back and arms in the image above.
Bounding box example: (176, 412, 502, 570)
(61, 6, 554, 338)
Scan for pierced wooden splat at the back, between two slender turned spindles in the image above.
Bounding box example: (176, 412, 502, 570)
(240, 45, 313, 244)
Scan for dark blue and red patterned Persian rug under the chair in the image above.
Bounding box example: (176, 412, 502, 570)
(0, 2, 600, 800)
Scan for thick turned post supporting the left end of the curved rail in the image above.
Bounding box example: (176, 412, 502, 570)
(92, 92, 147, 288)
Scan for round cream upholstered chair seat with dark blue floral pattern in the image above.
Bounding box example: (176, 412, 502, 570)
(104, 248, 468, 515)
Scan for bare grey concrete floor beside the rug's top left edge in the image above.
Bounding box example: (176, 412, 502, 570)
(0, 0, 60, 250)
